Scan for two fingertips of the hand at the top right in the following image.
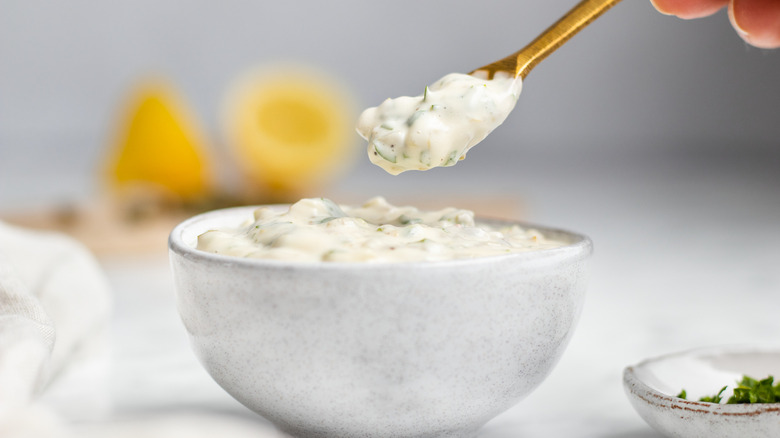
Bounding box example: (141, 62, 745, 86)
(650, 0, 780, 49)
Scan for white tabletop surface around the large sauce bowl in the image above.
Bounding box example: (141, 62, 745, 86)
(7, 148, 780, 438)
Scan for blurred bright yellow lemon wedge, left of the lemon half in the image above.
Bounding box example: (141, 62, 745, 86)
(109, 81, 212, 201)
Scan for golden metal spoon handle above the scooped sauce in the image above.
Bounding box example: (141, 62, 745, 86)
(470, 0, 620, 79)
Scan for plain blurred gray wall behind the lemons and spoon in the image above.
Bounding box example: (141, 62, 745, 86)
(0, 0, 780, 209)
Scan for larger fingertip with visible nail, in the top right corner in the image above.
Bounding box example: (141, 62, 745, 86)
(729, 0, 780, 49)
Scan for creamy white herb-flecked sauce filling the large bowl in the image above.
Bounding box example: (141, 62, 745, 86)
(197, 197, 565, 262)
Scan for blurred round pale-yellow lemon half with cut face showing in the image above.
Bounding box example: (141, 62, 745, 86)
(223, 65, 355, 197)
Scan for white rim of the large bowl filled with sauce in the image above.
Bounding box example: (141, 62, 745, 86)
(168, 204, 593, 270)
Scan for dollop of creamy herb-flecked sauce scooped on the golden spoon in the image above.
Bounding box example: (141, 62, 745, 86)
(357, 73, 522, 175)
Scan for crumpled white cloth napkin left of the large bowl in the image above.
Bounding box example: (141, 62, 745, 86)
(0, 222, 281, 438)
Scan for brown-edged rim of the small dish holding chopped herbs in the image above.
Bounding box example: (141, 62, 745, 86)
(623, 343, 780, 417)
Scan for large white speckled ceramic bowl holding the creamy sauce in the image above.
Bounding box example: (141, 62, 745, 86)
(169, 207, 592, 438)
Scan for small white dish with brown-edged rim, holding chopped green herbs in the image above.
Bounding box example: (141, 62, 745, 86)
(623, 346, 780, 438)
